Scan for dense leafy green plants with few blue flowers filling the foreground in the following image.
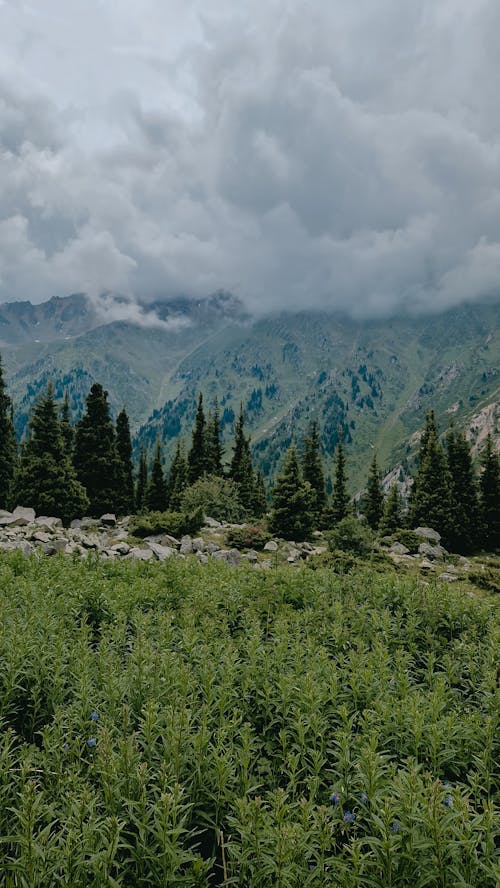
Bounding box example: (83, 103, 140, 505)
(0, 553, 499, 888)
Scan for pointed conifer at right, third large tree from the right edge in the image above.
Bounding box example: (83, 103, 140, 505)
(409, 412, 452, 545)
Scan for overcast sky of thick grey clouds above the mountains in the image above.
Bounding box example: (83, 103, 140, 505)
(0, 0, 500, 315)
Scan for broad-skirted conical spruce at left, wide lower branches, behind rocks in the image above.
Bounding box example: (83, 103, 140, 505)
(15, 384, 88, 524)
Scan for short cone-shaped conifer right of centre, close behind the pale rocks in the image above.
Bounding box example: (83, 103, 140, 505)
(269, 444, 315, 540)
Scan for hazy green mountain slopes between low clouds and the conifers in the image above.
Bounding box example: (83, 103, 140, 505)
(0, 293, 500, 489)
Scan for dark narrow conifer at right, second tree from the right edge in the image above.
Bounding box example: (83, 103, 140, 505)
(446, 425, 479, 552)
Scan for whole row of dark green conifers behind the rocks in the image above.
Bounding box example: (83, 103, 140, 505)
(0, 364, 500, 552)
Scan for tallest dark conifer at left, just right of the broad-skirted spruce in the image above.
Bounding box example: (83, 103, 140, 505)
(73, 382, 120, 516)
